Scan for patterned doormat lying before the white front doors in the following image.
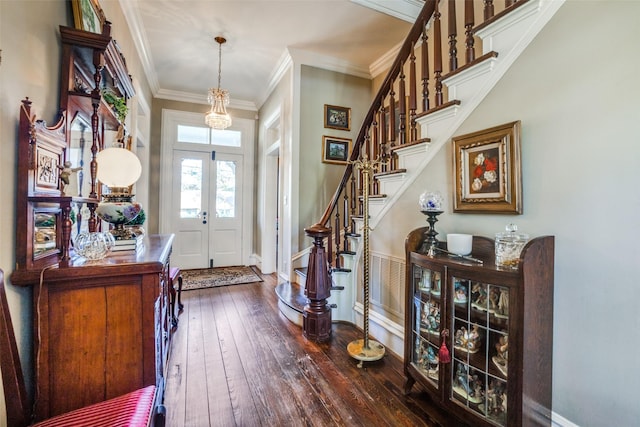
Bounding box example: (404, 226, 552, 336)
(182, 266, 262, 291)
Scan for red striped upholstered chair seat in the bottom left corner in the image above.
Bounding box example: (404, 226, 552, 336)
(35, 385, 156, 427)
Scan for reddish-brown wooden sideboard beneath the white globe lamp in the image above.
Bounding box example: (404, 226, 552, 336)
(12, 235, 173, 420)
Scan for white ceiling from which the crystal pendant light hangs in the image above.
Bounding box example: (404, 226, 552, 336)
(120, 0, 423, 110)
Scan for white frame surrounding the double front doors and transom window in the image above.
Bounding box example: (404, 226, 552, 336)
(158, 109, 255, 265)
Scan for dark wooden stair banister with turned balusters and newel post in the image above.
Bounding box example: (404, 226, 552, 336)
(303, 0, 528, 340)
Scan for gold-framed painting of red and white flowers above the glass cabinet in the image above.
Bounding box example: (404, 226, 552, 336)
(452, 121, 522, 214)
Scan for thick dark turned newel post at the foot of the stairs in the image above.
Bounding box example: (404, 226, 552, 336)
(302, 224, 331, 342)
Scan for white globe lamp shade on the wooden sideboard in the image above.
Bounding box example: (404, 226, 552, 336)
(96, 147, 142, 187)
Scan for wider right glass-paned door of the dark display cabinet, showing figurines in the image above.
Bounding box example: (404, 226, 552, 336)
(449, 275, 509, 426)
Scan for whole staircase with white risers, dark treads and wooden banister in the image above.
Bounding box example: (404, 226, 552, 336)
(277, 0, 564, 341)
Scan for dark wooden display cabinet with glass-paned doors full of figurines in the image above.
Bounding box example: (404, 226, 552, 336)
(405, 227, 554, 427)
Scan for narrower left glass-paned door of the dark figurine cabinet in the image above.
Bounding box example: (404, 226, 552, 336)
(411, 264, 442, 388)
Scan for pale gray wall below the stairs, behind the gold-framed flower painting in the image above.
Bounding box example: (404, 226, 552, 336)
(372, 1, 640, 426)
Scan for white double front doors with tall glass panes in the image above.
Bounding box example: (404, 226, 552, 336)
(170, 149, 243, 269)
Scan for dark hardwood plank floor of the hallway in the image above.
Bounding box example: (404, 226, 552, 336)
(165, 275, 458, 427)
